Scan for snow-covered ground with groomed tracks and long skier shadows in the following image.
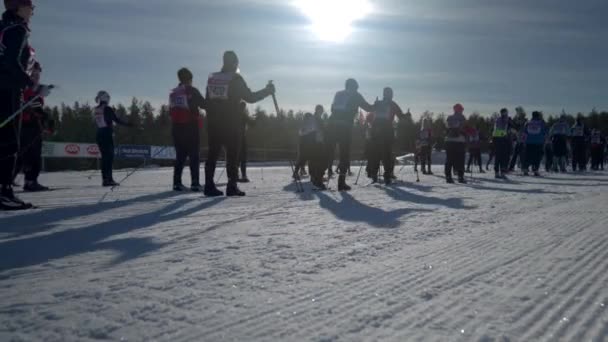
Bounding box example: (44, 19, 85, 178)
(0, 166, 608, 342)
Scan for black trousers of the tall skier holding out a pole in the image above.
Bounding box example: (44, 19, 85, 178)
(205, 121, 243, 185)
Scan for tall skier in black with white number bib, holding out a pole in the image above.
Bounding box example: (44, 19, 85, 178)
(204, 51, 275, 197)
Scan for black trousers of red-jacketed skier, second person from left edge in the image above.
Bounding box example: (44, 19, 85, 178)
(15, 123, 42, 182)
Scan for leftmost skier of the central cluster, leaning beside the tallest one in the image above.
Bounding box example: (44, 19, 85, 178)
(294, 105, 327, 190)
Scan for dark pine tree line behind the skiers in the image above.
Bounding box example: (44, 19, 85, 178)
(41, 98, 608, 170)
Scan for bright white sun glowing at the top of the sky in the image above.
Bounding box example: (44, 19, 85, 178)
(294, 0, 372, 42)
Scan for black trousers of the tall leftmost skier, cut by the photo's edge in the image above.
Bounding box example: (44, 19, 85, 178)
(0, 89, 21, 186)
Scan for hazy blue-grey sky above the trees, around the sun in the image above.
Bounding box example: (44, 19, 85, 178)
(31, 0, 608, 114)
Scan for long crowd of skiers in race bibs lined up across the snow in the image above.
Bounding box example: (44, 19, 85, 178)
(0, 0, 606, 210)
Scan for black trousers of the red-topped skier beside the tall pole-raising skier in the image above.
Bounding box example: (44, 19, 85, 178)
(172, 123, 201, 185)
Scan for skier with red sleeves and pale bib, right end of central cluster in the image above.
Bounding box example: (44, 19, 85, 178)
(368, 87, 405, 185)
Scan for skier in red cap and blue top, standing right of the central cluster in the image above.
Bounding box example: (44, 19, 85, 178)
(445, 103, 466, 183)
